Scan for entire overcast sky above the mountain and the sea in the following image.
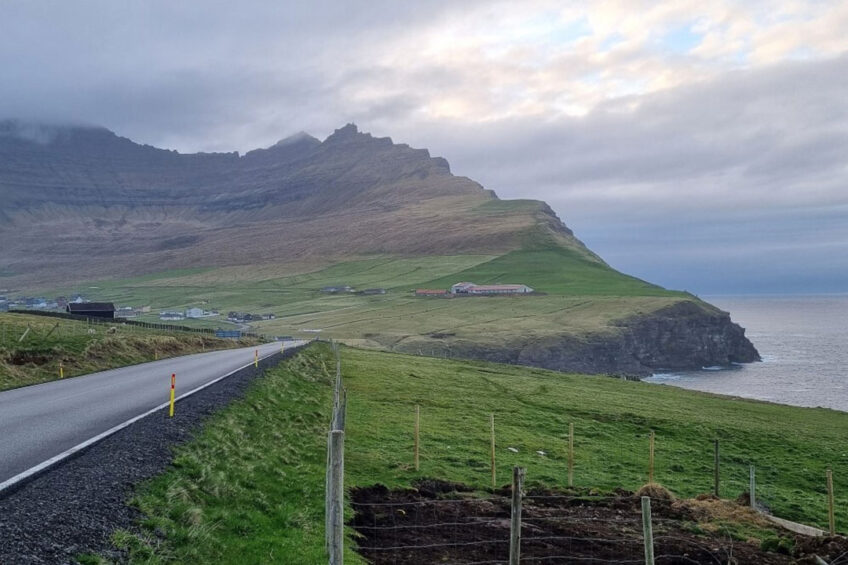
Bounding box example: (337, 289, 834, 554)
(0, 0, 848, 294)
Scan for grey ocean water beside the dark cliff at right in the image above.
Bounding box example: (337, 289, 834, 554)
(645, 294, 848, 412)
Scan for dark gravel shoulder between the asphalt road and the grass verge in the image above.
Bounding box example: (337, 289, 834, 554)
(0, 349, 296, 565)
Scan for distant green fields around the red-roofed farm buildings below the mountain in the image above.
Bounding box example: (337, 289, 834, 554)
(41, 251, 693, 348)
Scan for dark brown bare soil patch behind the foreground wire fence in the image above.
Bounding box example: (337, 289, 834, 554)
(351, 481, 848, 565)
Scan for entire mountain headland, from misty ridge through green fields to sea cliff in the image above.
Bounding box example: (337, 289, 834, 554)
(0, 122, 759, 375)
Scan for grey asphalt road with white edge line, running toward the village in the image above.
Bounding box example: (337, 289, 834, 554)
(0, 342, 304, 490)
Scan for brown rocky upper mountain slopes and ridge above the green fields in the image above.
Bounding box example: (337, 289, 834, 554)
(0, 122, 594, 285)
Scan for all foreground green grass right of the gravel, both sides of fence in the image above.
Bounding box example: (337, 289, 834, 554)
(114, 345, 848, 563)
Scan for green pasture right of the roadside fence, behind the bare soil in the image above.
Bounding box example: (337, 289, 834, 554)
(342, 348, 848, 528)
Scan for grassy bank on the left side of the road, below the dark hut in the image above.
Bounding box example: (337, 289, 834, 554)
(0, 313, 257, 390)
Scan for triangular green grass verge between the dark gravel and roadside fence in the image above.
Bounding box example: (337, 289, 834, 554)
(106, 346, 357, 564)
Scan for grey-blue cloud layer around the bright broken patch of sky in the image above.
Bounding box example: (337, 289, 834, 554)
(0, 0, 848, 292)
